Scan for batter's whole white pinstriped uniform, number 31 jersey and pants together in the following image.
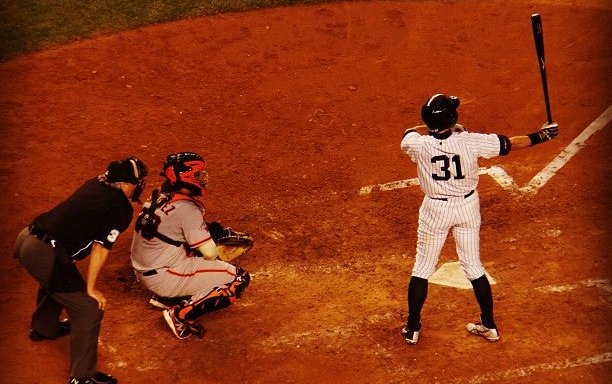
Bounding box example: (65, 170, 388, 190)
(401, 125, 510, 280)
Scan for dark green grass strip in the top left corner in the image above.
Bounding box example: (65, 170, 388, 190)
(0, 0, 329, 61)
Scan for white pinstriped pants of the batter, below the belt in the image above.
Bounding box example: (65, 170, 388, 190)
(412, 191, 485, 281)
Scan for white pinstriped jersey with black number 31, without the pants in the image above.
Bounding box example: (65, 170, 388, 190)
(401, 131, 501, 198)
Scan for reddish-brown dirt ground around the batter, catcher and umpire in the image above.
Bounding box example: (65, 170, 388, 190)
(0, 0, 612, 384)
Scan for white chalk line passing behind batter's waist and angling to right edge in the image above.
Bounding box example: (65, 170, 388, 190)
(359, 105, 612, 195)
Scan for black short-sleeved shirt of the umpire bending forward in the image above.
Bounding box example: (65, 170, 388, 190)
(32, 177, 134, 260)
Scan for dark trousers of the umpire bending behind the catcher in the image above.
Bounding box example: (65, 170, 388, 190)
(15, 228, 103, 378)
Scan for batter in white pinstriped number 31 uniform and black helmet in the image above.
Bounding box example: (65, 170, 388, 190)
(401, 94, 558, 344)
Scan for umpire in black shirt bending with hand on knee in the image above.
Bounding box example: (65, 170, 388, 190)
(15, 157, 147, 384)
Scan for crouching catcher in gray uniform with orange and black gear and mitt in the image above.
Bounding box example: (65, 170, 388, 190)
(131, 152, 253, 339)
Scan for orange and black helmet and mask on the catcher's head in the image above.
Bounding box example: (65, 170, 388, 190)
(161, 152, 208, 196)
